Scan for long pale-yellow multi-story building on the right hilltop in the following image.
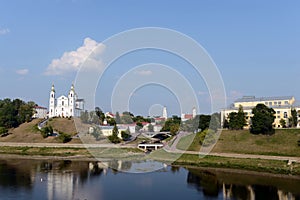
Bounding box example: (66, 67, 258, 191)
(221, 96, 300, 128)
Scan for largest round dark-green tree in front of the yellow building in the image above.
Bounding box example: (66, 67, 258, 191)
(250, 104, 275, 135)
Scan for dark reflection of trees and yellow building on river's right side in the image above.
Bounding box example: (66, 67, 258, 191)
(187, 169, 300, 200)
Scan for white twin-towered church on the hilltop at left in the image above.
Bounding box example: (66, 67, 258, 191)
(49, 84, 84, 118)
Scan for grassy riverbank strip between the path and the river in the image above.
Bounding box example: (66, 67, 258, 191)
(0, 146, 300, 175)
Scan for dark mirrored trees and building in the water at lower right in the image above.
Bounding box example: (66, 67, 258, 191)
(187, 170, 298, 200)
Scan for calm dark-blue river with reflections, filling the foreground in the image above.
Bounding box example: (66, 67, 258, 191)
(0, 159, 300, 200)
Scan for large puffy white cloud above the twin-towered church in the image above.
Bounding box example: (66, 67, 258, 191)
(45, 38, 104, 75)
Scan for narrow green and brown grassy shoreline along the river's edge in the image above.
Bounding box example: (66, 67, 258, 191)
(0, 144, 300, 178)
